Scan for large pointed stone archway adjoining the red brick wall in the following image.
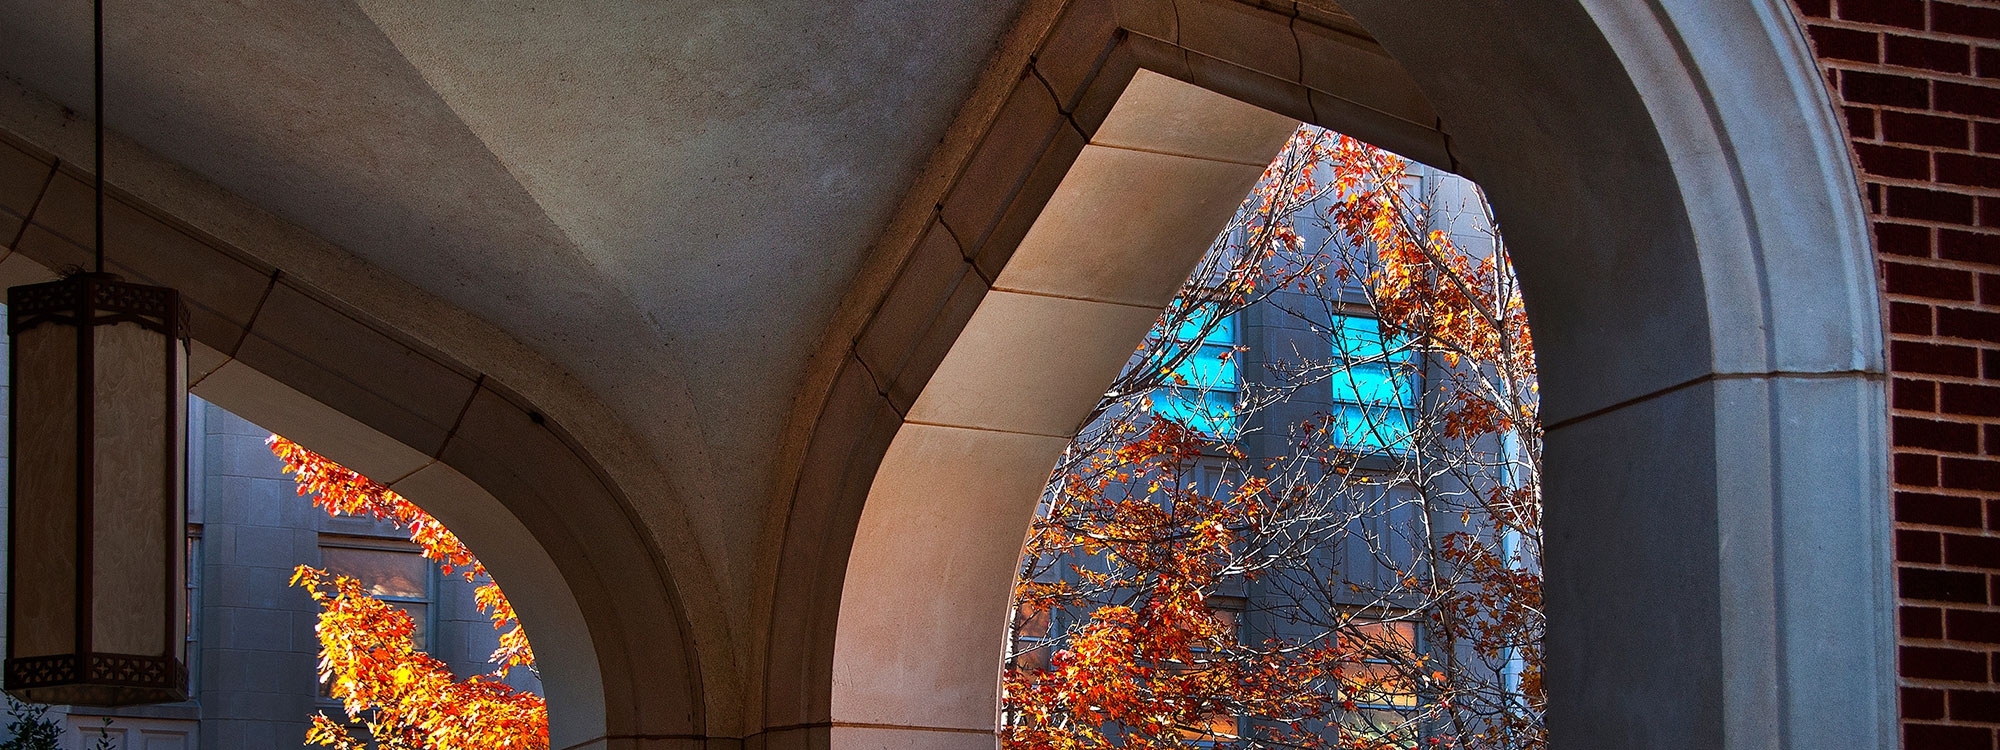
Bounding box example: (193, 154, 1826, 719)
(766, 0, 1896, 748)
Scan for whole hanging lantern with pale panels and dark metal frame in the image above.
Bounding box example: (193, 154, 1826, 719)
(6, 272, 188, 706)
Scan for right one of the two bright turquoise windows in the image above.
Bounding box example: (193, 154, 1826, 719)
(1330, 316, 1416, 452)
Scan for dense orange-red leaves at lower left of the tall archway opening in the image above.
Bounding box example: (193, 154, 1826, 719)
(1004, 420, 1342, 748)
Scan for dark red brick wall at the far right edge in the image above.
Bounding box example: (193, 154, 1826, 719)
(1796, 0, 2000, 750)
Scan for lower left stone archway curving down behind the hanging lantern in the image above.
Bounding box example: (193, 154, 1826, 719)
(0, 134, 706, 750)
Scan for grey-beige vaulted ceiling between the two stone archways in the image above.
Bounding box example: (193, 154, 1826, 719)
(0, 0, 1014, 584)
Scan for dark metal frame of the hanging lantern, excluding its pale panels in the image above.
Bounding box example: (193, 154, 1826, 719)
(4, 272, 188, 706)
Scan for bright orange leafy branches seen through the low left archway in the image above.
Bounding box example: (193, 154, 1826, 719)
(268, 434, 548, 750)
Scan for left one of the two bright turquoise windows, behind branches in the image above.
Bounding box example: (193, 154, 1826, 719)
(1152, 308, 1242, 438)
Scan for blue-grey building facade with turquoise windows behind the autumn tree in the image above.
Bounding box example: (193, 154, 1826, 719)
(1008, 156, 1540, 748)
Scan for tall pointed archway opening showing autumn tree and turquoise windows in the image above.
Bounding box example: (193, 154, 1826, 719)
(1002, 128, 1542, 750)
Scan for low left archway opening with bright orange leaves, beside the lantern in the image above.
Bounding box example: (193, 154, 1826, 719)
(0, 296, 548, 750)
